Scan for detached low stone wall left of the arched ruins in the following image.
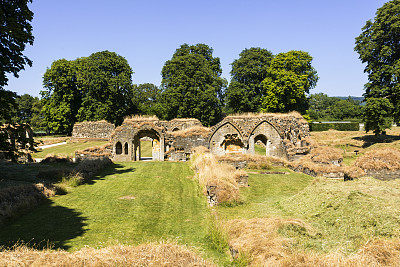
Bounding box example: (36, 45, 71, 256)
(71, 121, 115, 141)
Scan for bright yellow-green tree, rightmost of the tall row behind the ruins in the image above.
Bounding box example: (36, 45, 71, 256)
(261, 51, 318, 113)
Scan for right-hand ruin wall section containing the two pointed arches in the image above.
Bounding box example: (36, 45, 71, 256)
(208, 112, 310, 160)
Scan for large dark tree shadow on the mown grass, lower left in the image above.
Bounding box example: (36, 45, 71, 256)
(0, 200, 86, 249)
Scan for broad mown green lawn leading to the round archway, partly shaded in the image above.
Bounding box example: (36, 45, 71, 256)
(0, 162, 210, 253)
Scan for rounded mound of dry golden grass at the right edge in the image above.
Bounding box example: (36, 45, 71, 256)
(354, 147, 400, 170)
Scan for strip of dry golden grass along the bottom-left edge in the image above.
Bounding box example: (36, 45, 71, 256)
(0, 243, 215, 266)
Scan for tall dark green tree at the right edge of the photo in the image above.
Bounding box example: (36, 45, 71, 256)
(354, 0, 400, 134)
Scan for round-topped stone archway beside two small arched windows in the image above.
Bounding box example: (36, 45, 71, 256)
(132, 125, 165, 161)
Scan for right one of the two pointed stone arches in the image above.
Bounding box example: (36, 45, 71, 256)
(248, 120, 286, 157)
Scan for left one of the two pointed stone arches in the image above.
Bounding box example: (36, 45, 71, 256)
(208, 121, 247, 155)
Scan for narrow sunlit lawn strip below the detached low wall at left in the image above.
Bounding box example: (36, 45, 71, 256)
(32, 141, 108, 158)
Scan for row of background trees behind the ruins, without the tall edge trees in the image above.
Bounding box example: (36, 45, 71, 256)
(5, 44, 366, 134)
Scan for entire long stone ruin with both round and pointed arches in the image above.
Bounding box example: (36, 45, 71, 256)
(101, 112, 310, 161)
